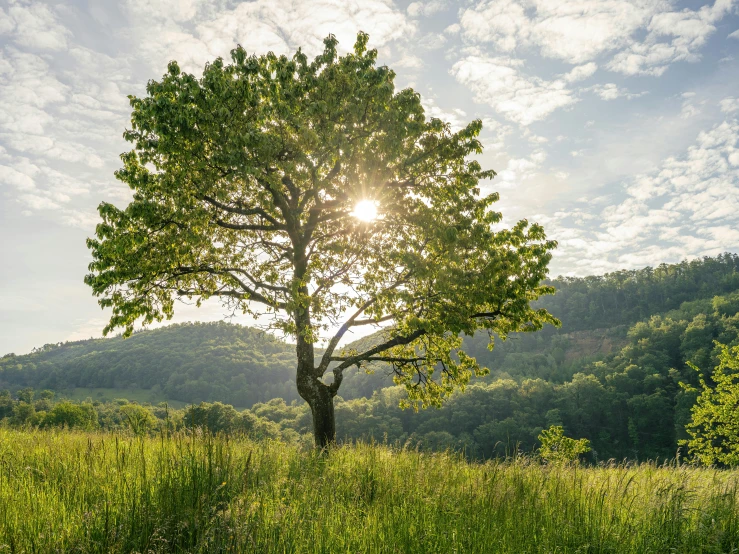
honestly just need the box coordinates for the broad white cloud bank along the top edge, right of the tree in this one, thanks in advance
[460,0,733,75]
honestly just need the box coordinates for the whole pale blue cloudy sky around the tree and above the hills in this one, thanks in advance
[0,0,739,355]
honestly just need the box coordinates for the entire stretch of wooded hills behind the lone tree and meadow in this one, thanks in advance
[0,254,739,461]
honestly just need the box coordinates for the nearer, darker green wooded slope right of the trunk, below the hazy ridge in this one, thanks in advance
[252,291,739,461]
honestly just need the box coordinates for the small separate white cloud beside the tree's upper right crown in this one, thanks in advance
[451,55,578,125]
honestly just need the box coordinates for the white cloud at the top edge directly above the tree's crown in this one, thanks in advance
[125,0,416,71]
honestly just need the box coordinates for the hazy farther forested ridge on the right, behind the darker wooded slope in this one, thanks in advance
[340,253,739,398]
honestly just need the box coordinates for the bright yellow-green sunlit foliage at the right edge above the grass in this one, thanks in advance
[680,342,739,467]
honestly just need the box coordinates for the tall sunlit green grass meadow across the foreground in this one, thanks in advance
[0,428,739,554]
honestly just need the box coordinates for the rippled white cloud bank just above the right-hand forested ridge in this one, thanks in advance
[541,121,739,273]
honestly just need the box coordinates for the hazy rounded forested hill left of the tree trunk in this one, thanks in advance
[0,323,297,407]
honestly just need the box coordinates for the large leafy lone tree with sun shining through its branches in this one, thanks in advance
[85,33,558,446]
